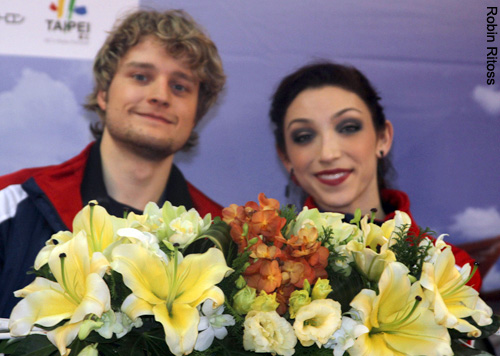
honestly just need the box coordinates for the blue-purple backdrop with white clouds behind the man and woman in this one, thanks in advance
[0,0,500,300]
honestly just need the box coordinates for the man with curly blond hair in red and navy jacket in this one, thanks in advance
[0,10,225,317]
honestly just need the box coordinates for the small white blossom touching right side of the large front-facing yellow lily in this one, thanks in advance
[194,299,235,351]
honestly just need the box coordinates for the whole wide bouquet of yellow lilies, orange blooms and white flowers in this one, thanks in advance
[0,194,500,356]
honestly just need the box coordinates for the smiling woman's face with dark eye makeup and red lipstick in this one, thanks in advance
[280,86,392,213]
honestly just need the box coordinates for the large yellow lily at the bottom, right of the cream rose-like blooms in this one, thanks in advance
[348,262,453,356]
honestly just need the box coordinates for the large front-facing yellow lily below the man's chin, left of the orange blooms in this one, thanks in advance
[112,244,232,355]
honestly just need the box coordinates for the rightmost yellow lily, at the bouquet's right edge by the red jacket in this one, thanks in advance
[420,246,493,337]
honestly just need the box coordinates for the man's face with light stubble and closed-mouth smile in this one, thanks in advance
[97,37,199,160]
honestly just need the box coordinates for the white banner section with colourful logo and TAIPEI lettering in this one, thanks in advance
[0,0,139,59]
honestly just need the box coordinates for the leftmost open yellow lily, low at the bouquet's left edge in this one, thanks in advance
[9,232,111,355]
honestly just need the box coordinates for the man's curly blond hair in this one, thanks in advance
[85,10,226,149]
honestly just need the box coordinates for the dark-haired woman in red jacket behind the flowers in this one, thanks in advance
[270,62,481,290]
